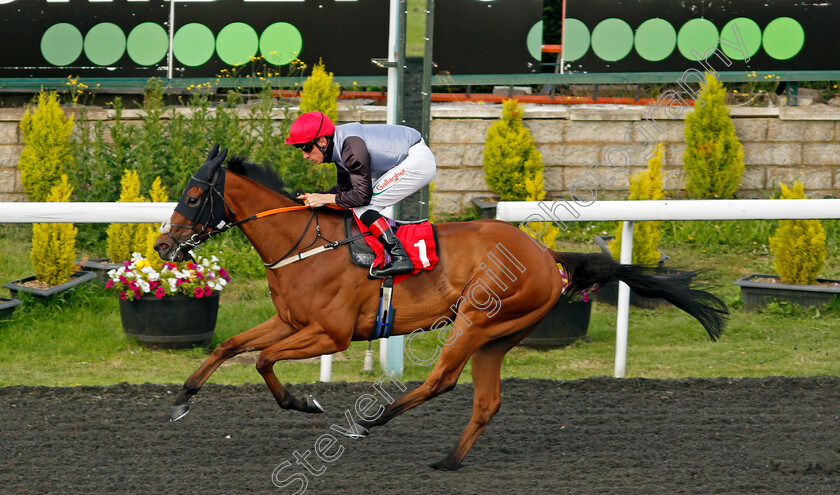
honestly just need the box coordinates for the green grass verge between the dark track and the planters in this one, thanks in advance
[0,226,840,386]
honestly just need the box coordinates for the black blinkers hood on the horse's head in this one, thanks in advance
[175,144,228,229]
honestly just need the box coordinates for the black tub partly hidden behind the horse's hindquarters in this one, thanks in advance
[520,297,592,347]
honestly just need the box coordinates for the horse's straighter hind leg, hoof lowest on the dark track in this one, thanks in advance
[432,330,528,471]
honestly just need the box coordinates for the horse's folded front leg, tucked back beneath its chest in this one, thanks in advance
[257,323,352,413]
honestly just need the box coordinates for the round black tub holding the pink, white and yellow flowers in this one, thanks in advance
[120,292,219,349]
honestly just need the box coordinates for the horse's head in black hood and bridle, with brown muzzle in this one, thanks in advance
[155,144,231,261]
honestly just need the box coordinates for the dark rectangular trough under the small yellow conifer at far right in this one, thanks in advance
[735,273,840,311]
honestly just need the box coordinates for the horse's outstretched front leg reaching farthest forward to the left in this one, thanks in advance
[170,315,295,421]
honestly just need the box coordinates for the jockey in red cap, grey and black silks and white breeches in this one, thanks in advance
[286,112,435,278]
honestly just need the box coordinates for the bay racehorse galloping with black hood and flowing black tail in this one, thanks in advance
[155,146,728,470]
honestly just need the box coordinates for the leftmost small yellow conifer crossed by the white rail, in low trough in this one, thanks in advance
[30,174,79,286]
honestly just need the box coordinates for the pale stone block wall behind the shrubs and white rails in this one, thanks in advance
[0,104,840,213]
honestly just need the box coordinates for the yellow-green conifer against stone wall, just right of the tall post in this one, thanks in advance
[483,99,544,201]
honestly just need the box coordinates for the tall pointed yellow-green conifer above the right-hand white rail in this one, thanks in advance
[683,73,744,199]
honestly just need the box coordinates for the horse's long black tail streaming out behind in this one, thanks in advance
[552,251,729,340]
